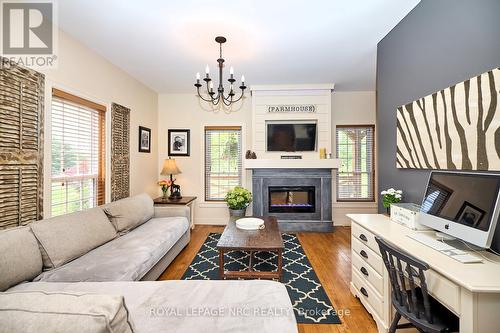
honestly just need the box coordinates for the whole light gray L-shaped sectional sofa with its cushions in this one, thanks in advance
[0,194,297,333]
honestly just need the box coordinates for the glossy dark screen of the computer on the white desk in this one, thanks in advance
[420,172,500,231]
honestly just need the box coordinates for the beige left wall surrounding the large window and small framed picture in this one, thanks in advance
[44,31,158,212]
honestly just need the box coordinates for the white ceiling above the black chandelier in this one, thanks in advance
[58,0,419,93]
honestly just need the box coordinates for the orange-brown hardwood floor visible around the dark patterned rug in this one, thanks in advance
[160,225,377,333]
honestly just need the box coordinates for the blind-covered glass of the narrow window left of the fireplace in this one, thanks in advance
[205,126,242,201]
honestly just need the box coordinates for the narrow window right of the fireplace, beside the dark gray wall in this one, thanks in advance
[337,125,375,201]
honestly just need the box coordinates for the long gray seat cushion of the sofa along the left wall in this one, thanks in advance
[35,217,189,282]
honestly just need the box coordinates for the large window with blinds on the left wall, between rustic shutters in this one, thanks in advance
[51,89,106,216]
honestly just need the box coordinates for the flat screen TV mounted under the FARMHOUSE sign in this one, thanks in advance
[267,123,316,152]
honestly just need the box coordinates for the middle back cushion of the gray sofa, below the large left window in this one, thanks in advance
[30,208,117,268]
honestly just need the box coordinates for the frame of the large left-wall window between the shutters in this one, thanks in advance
[50,87,107,217]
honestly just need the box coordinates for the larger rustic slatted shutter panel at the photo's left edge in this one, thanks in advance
[0,58,44,229]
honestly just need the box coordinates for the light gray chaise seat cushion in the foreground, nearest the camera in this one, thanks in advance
[8,280,297,333]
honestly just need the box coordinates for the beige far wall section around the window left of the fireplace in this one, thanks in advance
[156,92,252,224]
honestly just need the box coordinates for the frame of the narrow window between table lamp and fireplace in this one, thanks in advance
[200,124,245,201]
